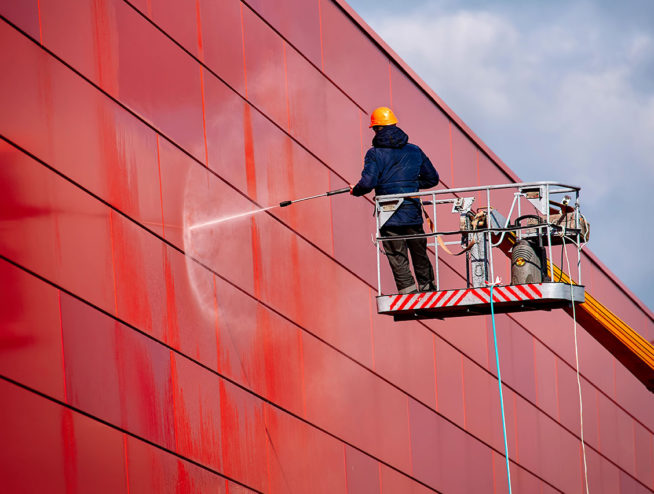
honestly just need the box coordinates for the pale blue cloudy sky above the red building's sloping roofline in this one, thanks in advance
[348,0,654,310]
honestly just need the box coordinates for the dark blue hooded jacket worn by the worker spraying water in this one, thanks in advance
[352,125,438,226]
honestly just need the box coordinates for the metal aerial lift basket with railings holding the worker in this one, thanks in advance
[375,182,589,320]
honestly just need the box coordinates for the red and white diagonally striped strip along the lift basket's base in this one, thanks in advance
[389,283,543,311]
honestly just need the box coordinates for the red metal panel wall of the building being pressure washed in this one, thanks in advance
[0,0,654,494]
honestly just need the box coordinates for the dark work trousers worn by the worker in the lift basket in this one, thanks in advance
[380,225,436,293]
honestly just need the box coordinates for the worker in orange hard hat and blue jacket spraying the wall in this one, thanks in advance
[350,107,438,293]
